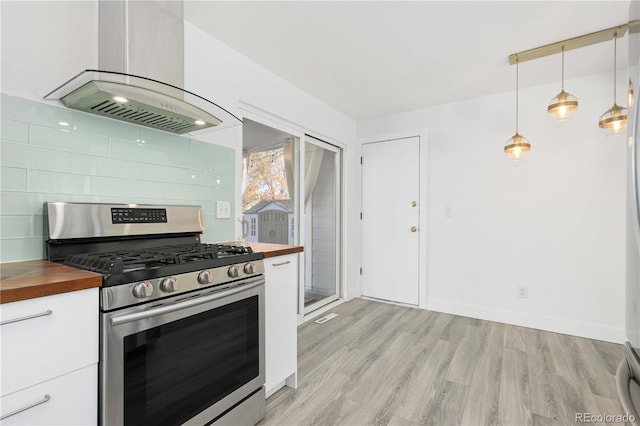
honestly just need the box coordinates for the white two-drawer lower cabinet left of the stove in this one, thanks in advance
[0,288,99,425]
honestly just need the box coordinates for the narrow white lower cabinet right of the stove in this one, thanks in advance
[264,253,298,396]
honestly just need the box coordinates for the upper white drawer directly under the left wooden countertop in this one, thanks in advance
[0,288,98,396]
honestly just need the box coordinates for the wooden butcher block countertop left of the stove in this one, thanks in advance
[0,260,102,303]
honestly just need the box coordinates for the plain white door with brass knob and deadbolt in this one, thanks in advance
[362,136,420,305]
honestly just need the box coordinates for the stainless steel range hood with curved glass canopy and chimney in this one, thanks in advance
[45,0,241,134]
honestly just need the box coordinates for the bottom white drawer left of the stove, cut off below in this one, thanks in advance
[0,364,98,426]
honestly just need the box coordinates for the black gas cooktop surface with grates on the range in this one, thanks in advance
[64,244,263,286]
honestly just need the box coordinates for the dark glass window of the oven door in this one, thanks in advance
[124,296,260,425]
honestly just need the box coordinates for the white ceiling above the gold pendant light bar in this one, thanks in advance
[185,0,629,119]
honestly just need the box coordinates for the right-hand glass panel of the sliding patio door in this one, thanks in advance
[301,135,341,313]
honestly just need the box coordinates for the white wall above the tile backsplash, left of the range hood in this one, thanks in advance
[0,1,98,102]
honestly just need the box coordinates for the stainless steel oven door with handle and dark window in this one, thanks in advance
[100,276,264,425]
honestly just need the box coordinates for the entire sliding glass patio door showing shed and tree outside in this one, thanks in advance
[242,118,342,315]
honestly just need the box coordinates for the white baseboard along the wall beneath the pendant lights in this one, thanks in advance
[427,299,627,343]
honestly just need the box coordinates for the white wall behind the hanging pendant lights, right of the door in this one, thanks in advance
[358,70,626,342]
